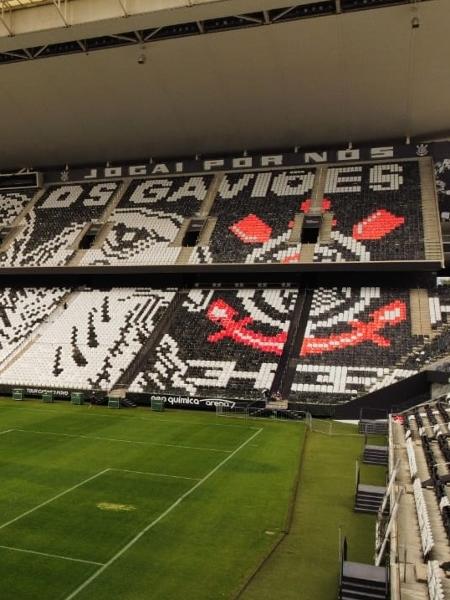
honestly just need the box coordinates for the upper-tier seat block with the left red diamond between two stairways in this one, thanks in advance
[190,169,315,264]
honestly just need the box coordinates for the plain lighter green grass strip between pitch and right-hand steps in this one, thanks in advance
[241,424,385,600]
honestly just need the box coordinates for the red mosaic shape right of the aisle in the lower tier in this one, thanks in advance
[300,300,406,356]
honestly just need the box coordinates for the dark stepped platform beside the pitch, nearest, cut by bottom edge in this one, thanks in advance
[339,561,388,600]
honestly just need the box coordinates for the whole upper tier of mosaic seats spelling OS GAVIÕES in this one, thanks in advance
[0,159,425,267]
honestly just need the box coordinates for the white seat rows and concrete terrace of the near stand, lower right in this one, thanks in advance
[391,403,448,600]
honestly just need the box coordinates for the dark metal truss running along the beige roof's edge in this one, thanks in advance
[0,0,431,65]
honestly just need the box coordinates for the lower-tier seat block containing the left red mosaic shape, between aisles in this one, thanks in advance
[130,289,297,399]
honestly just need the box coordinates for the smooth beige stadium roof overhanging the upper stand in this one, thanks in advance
[0,0,450,169]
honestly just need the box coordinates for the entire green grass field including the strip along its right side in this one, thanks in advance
[0,399,383,600]
